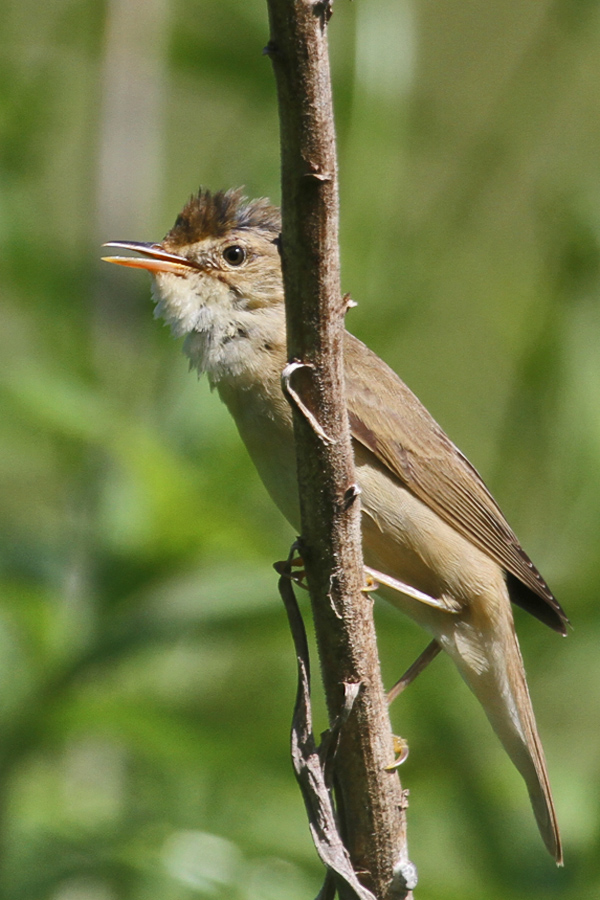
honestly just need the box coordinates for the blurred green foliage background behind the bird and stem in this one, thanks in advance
[0,0,600,900]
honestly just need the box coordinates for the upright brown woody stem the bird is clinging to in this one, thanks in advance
[267,0,414,900]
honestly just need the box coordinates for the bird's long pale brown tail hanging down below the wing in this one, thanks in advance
[439,609,563,866]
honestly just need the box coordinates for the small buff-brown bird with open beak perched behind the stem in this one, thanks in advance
[106,190,568,865]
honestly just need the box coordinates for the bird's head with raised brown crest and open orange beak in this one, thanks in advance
[105,189,283,374]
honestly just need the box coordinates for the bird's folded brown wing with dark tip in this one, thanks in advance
[345,334,568,634]
